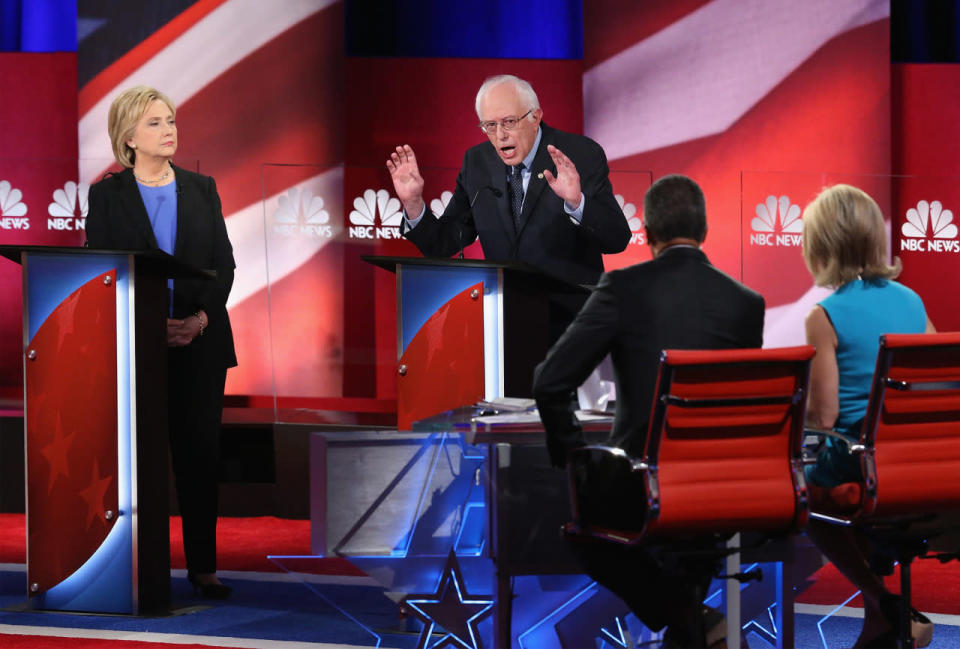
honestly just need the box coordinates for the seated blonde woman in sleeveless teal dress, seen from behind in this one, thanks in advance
[803,185,934,649]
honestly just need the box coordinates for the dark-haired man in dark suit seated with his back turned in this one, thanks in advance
[534,176,764,647]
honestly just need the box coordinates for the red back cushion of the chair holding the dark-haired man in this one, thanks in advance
[645,346,814,535]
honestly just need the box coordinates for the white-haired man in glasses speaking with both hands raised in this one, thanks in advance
[387,75,630,284]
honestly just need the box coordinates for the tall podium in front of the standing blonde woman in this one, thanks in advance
[0,246,212,615]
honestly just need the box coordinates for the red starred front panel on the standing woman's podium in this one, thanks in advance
[24,268,119,592]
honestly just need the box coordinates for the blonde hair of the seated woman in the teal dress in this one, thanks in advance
[803,185,901,287]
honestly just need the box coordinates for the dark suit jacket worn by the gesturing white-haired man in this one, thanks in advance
[405,122,630,284]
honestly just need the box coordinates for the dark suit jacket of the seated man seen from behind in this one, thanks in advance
[534,247,764,466]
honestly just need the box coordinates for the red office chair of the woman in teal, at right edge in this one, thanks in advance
[811,333,960,647]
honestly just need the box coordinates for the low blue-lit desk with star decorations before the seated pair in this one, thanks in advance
[311,409,808,649]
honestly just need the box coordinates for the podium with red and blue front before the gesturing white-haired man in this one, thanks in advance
[363,255,587,430]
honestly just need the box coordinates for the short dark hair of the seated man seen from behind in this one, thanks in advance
[643,174,707,243]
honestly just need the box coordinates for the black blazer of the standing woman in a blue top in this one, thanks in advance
[86,166,237,367]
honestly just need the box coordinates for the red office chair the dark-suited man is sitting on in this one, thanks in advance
[566,346,814,634]
